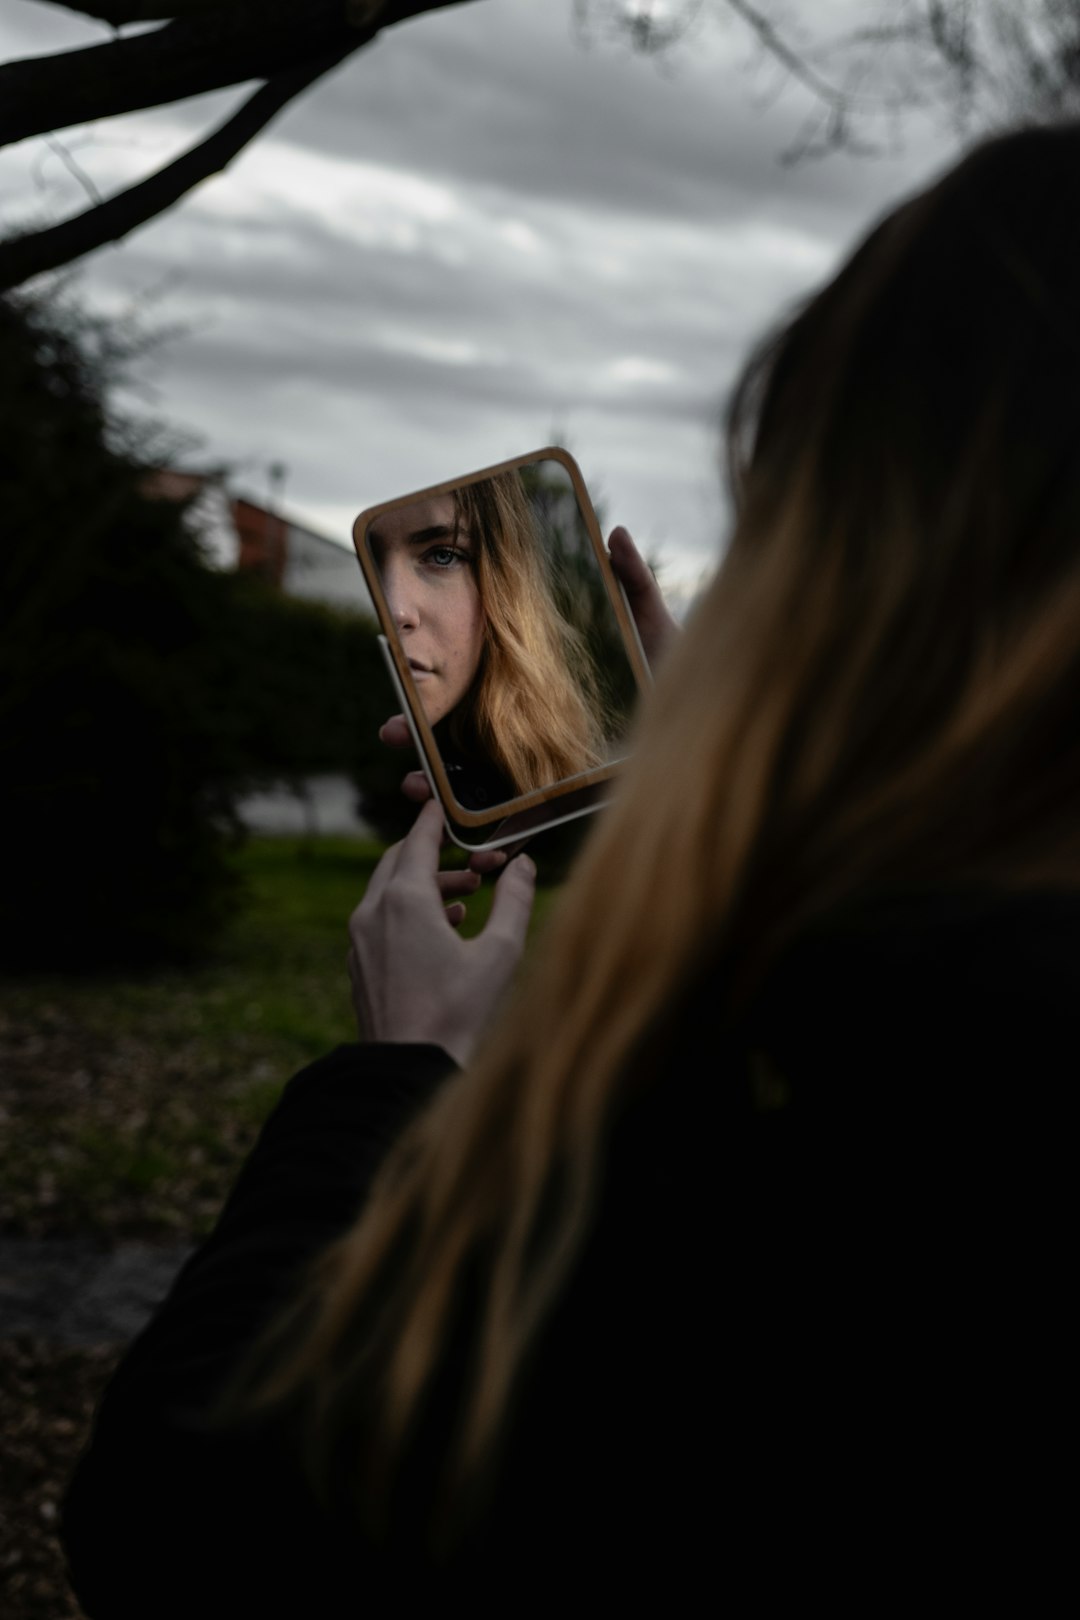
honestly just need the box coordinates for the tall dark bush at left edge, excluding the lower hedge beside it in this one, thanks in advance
[0,300,246,969]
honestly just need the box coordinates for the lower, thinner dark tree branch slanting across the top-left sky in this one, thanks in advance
[0,45,358,292]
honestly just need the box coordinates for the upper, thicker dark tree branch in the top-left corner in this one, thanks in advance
[0,0,482,146]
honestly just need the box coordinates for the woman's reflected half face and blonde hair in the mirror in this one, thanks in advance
[368,468,609,808]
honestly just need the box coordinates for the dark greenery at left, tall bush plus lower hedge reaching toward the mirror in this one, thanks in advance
[0,298,400,970]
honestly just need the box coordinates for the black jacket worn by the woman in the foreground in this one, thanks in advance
[63,896,1080,1620]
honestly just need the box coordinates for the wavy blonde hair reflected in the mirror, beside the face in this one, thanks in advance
[450,470,606,794]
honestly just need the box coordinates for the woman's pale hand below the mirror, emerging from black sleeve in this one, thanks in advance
[348,800,536,1064]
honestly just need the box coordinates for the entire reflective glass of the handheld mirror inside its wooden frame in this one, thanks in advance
[366,458,638,810]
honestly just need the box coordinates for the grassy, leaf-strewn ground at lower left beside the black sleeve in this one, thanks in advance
[0,838,374,1620]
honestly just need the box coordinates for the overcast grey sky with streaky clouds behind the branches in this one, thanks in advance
[0,0,954,609]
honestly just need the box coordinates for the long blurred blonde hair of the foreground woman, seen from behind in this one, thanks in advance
[236,130,1080,1521]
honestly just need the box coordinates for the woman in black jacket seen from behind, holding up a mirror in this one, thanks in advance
[68,126,1080,1617]
